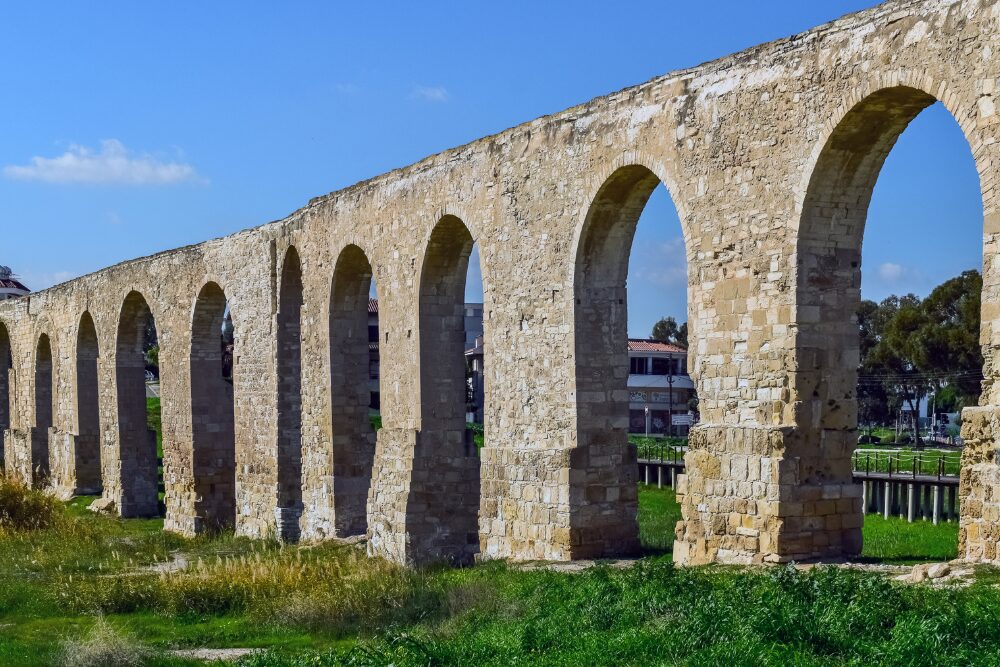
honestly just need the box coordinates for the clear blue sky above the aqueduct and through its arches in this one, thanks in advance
[0,0,982,335]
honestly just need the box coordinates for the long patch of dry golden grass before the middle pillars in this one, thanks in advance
[60,545,449,634]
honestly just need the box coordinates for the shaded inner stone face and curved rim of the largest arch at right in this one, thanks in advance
[792,83,989,558]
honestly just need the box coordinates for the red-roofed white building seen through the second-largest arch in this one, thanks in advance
[628,338,695,436]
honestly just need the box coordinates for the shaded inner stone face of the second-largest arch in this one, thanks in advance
[570,163,693,557]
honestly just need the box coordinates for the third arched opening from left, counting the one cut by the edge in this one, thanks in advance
[75,312,101,495]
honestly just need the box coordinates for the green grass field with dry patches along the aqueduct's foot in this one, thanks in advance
[0,470,984,667]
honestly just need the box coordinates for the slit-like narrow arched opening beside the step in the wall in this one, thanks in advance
[275,247,302,541]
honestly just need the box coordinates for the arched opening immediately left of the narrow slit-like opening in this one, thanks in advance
[190,282,236,530]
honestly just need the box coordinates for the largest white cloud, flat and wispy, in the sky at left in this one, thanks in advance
[3,139,200,185]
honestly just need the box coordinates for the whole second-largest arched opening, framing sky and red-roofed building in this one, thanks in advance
[570,165,693,558]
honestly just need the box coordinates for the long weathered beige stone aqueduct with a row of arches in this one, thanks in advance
[0,0,1000,564]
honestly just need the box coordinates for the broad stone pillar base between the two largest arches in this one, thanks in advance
[674,424,862,565]
